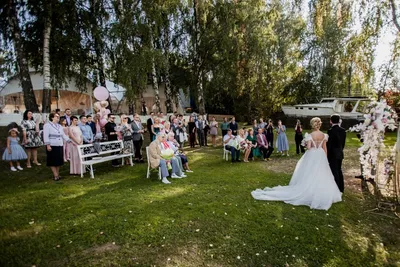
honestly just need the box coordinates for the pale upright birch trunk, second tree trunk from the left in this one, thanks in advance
[42,12,51,113]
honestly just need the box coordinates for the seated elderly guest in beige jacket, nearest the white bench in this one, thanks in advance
[149,133,186,184]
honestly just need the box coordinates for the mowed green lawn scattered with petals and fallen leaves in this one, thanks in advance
[0,128,400,266]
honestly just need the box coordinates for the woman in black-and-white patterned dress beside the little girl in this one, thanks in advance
[21,110,43,168]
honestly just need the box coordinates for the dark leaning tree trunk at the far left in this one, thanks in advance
[7,0,39,112]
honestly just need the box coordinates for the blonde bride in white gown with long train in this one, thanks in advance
[251,118,342,210]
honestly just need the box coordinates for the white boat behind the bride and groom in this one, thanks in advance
[282,97,371,120]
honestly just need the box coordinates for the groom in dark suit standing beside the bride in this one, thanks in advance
[326,114,346,193]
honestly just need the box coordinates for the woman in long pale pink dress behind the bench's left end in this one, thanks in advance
[69,116,83,175]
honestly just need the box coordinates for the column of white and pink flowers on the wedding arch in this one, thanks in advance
[349,100,397,179]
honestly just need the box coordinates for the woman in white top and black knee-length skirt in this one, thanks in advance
[43,113,70,181]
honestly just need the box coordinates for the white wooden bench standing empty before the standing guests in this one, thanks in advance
[78,140,133,178]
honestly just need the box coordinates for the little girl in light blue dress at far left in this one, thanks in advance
[3,128,28,172]
